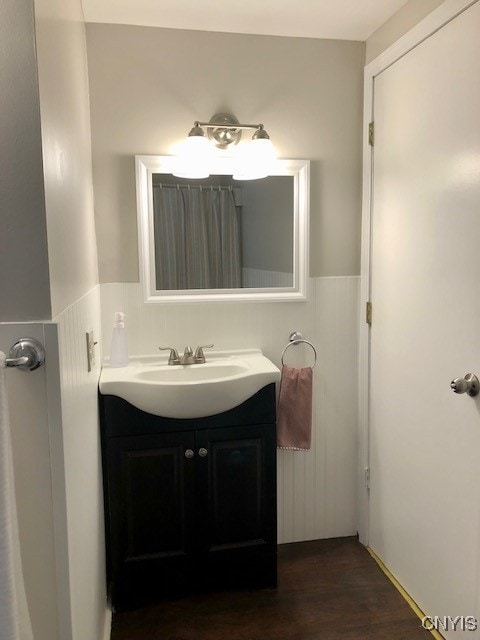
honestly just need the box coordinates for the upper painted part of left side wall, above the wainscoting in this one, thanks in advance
[35,0,98,317]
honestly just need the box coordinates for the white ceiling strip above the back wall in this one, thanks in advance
[82,0,406,40]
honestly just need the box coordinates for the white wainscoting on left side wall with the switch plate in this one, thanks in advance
[54,287,111,640]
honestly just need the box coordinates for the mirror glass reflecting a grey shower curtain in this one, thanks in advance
[152,173,293,290]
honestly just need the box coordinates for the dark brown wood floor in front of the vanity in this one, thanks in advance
[111,538,432,640]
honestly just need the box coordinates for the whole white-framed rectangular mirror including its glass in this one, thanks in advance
[135,156,310,303]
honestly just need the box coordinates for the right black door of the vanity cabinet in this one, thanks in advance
[196,425,276,586]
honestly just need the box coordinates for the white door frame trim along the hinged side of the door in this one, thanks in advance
[357,0,480,546]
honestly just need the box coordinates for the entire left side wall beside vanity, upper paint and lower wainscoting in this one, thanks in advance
[35,0,110,640]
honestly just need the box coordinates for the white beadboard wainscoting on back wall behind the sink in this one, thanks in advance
[100,277,359,542]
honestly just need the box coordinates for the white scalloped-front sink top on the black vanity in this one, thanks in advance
[99,349,280,418]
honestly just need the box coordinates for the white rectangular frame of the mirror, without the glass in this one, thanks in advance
[135,155,310,304]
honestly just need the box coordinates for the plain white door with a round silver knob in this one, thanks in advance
[369,3,480,638]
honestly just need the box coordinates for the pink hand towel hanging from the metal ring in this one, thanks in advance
[277,364,313,451]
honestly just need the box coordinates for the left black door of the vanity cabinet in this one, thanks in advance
[107,431,195,609]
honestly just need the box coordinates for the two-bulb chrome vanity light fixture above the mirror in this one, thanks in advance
[173,113,276,180]
